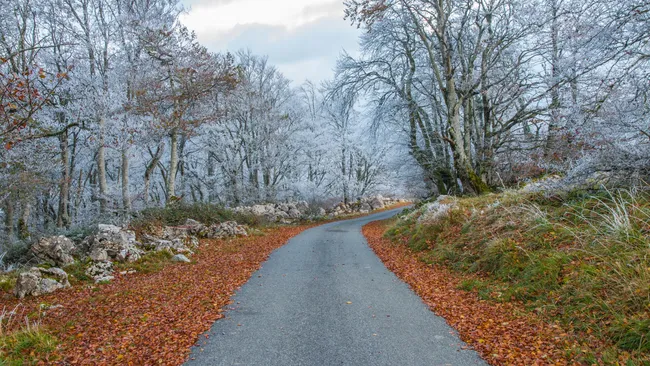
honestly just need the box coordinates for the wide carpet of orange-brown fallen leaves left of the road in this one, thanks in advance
[0,226,308,365]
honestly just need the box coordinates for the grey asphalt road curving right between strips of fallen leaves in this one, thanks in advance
[186,210,485,366]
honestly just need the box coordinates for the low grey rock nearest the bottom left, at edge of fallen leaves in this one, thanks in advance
[14,267,70,299]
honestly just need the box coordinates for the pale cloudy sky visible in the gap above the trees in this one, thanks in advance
[181,0,360,84]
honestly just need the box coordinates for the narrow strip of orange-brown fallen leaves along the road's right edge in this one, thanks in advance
[363,222,579,366]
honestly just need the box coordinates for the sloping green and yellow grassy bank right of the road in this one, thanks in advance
[386,189,650,365]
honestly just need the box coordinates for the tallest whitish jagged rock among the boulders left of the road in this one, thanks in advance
[82,225,144,262]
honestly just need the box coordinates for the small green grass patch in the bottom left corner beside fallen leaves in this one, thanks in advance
[0,307,58,366]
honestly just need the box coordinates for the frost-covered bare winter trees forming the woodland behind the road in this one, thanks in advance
[0,0,650,250]
